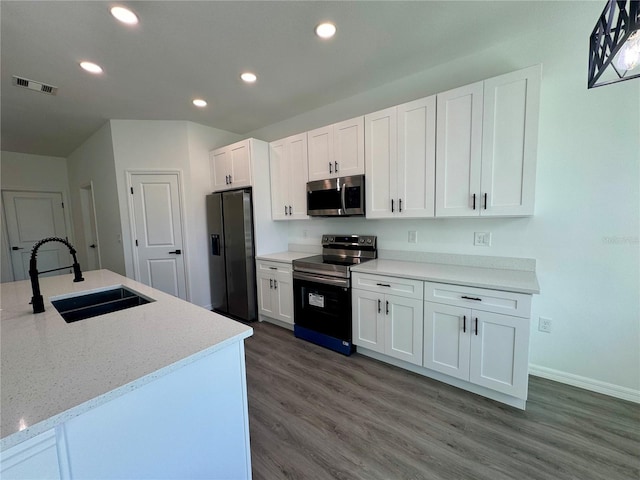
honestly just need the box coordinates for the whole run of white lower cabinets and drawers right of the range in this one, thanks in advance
[352,272,531,408]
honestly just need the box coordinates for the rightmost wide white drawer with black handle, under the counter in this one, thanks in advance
[424,282,531,318]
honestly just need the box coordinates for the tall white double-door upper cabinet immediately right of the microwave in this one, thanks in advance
[365,96,436,218]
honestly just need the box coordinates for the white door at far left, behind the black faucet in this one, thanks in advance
[2,190,73,281]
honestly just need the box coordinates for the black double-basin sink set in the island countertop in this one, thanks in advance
[51,286,154,323]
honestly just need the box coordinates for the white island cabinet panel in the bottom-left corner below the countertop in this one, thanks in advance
[0,429,60,480]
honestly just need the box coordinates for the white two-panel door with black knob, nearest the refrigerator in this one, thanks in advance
[130,173,187,300]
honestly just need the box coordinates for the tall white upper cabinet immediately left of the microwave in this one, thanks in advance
[269,133,309,220]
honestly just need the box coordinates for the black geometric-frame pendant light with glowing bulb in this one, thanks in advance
[587,0,640,88]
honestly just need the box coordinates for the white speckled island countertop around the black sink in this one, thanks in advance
[0,270,253,450]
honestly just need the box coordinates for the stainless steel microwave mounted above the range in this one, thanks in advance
[307,175,364,217]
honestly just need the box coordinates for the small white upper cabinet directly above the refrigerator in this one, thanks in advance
[209,139,252,192]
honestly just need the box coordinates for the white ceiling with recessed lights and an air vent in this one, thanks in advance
[0,0,576,157]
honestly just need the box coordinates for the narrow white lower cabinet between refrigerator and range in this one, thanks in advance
[256,260,293,326]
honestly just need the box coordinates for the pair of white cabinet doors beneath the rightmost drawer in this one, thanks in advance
[424,302,529,399]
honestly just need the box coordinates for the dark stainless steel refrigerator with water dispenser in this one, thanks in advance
[207,189,257,322]
